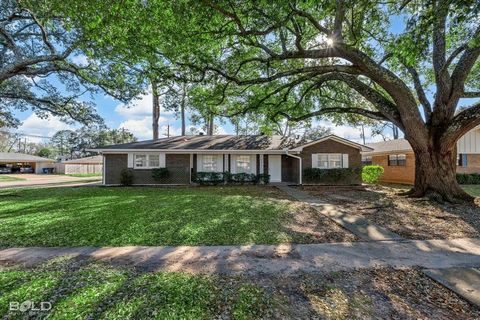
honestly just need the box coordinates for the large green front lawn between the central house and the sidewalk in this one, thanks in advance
[0,186,305,247]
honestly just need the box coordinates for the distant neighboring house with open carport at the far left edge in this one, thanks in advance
[0,152,55,173]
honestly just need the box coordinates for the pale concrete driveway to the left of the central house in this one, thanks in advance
[0,173,102,189]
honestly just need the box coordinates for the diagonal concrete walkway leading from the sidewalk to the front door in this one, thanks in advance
[276,184,403,241]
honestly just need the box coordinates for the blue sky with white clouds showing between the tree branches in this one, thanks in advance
[8,13,404,142]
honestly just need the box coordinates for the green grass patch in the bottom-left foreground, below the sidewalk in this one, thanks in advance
[0,260,269,319]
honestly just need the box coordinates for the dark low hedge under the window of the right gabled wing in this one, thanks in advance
[303,167,362,184]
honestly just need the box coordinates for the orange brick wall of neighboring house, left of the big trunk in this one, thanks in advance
[372,153,415,184]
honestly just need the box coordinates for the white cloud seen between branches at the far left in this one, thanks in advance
[18,113,75,142]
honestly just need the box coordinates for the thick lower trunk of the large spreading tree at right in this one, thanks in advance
[406,146,474,202]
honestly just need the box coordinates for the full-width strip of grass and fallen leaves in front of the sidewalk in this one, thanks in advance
[0,256,480,319]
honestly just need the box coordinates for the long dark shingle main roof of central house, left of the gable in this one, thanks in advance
[98,135,284,150]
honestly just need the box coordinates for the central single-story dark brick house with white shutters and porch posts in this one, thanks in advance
[89,135,369,185]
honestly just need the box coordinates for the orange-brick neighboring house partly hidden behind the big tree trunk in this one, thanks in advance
[362,127,480,184]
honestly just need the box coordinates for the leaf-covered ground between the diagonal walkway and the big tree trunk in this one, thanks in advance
[302,186,480,240]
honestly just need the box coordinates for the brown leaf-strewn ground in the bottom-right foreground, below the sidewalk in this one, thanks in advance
[257,268,480,319]
